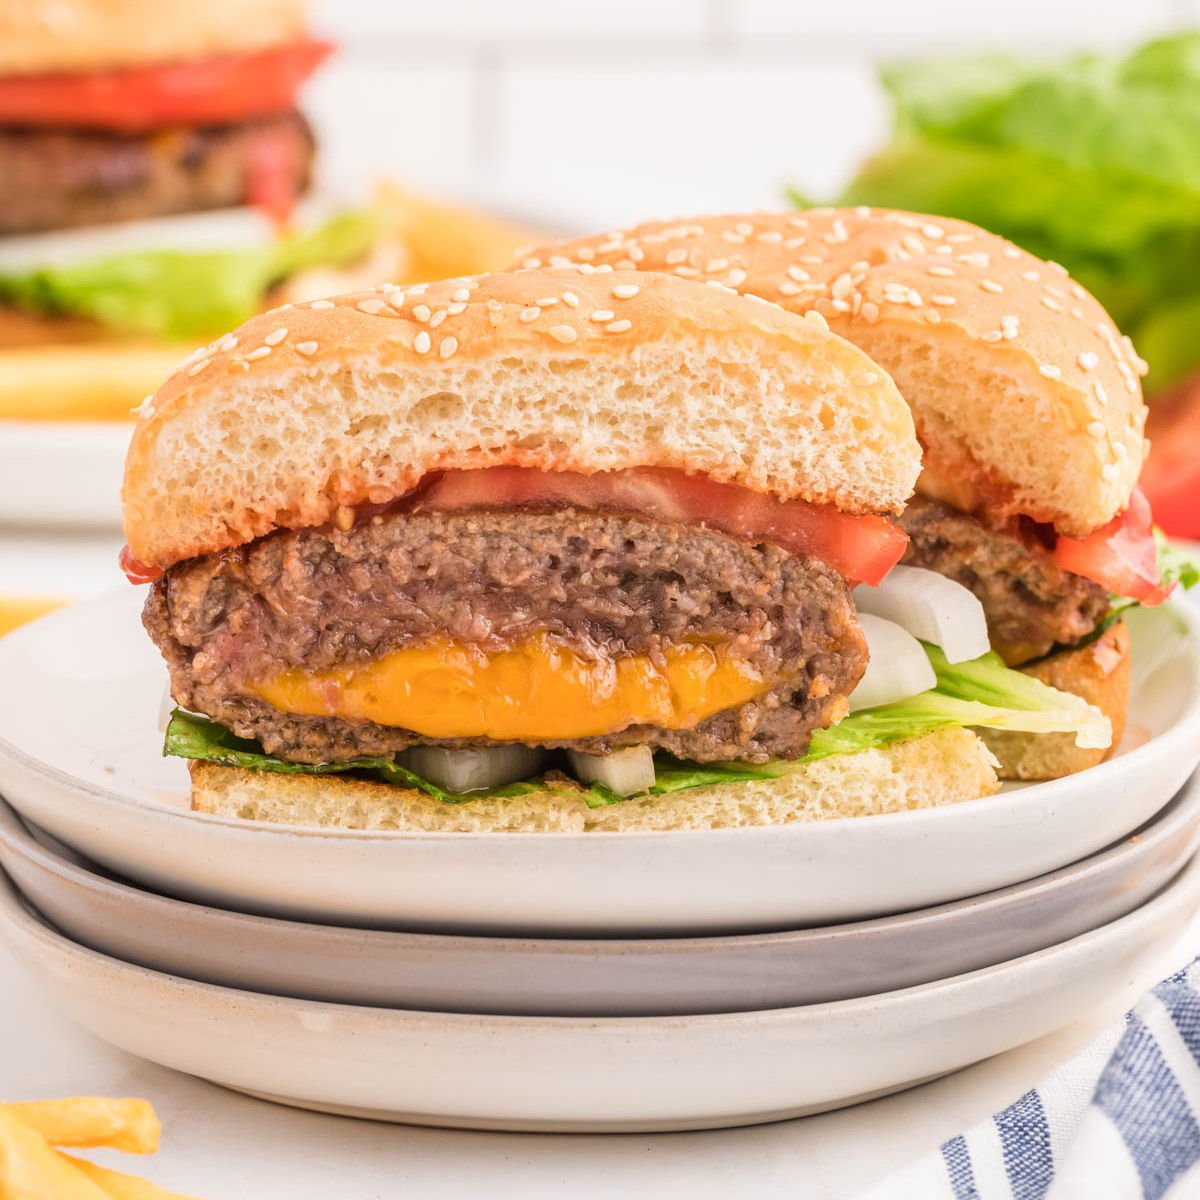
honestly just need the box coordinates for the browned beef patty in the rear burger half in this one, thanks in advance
[900,496,1109,666]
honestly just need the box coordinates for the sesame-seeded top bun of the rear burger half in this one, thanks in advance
[520,208,1147,536]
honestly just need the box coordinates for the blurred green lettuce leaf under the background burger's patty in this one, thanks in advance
[0,212,378,338]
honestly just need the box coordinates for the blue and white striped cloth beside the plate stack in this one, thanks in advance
[859,959,1200,1200]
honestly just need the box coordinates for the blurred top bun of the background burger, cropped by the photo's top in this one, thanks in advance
[0,0,306,74]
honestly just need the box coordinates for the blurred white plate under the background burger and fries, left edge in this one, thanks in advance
[0,421,133,529]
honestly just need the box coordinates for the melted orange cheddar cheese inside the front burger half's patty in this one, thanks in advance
[251,635,770,742]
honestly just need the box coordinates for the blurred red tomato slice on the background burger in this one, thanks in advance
[0,38,334,133]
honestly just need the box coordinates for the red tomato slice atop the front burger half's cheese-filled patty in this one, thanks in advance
[414,467,908,583]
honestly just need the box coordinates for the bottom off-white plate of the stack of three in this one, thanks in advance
[0,862,1200,1132]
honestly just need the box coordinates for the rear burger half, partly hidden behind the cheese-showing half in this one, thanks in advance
[522,208,1190,779]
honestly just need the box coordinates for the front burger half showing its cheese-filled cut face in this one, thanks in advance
[124,268,1106,830]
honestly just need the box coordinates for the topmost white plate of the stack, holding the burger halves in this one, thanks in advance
[0,588,1200,936]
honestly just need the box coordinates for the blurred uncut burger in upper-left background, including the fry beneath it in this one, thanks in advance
[0,0,384,420]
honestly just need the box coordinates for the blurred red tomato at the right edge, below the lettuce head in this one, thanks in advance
[1141,374,1200,539]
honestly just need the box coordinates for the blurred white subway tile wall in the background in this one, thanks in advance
[306,0,1200,230]
